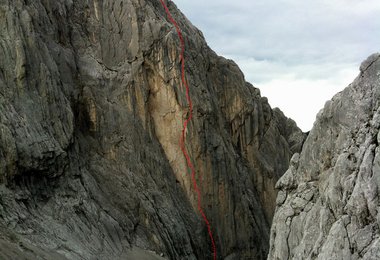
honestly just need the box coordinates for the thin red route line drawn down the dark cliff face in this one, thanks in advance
[160,0,216,260]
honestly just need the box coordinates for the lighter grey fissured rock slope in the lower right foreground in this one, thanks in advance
[268,54,380,260]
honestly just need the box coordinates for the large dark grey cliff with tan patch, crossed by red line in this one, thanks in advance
[0,0,304,260]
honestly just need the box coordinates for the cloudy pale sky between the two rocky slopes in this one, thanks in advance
[174,0,380,131]
